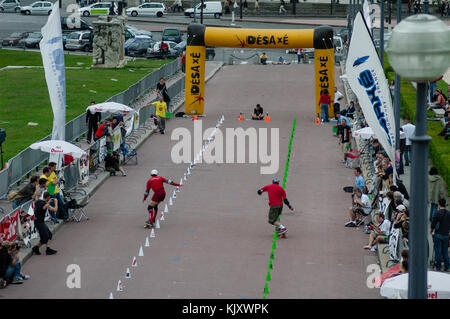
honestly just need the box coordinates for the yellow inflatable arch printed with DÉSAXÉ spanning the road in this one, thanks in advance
[185,23,334,117]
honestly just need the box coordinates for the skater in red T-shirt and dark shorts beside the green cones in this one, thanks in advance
[258,177,294,238]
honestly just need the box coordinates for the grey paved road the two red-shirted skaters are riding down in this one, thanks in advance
[0,65,379,299]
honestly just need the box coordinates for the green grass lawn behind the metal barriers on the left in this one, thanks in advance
[0,50,174,162]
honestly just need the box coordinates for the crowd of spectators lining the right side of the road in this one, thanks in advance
[335,88,450,278]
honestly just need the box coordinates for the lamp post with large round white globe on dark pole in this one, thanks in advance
[386,14,450,299]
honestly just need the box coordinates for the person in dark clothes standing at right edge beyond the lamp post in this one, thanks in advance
[431,198,450,271]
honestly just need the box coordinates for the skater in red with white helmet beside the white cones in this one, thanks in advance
[142,169,181,228]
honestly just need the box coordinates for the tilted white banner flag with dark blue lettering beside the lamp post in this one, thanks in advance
[345,12,396,174]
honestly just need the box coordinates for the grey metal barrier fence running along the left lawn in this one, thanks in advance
[0,59,181,199]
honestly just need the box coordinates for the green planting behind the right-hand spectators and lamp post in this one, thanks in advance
[384,56,450,192]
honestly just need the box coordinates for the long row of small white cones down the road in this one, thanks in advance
[109,115,225,299]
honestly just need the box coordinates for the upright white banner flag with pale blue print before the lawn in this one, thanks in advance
[39,1,66,165]
